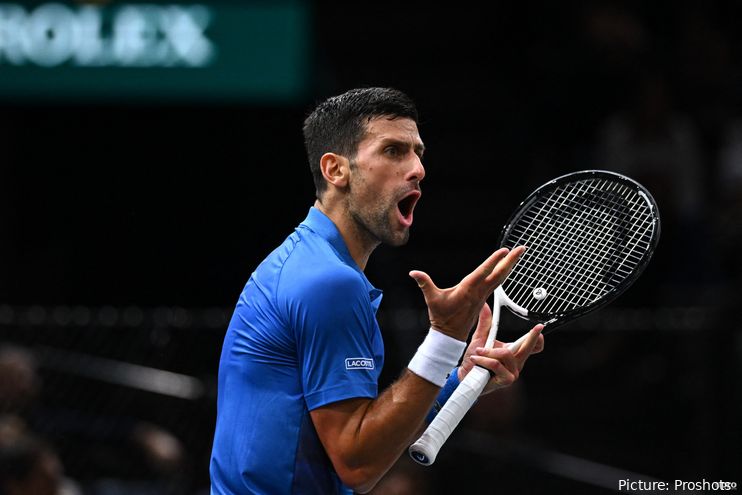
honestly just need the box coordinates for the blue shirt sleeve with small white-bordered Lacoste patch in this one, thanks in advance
[286,266,381,411]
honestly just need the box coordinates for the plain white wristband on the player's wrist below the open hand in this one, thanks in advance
[407,327,466,387]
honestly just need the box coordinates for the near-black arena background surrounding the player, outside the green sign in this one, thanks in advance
[0,1,742,493]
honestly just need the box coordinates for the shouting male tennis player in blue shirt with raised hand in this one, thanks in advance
[210,88,543,495]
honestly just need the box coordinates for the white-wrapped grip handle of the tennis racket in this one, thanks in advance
[409,366,490,466]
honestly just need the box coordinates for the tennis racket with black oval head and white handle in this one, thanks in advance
[409,170,660,466]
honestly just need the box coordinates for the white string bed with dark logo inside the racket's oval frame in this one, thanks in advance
[503,179,654,312]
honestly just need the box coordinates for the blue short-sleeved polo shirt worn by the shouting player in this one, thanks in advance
[210,208,384,495]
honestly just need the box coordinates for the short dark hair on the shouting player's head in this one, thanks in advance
[304,88,418,198]
